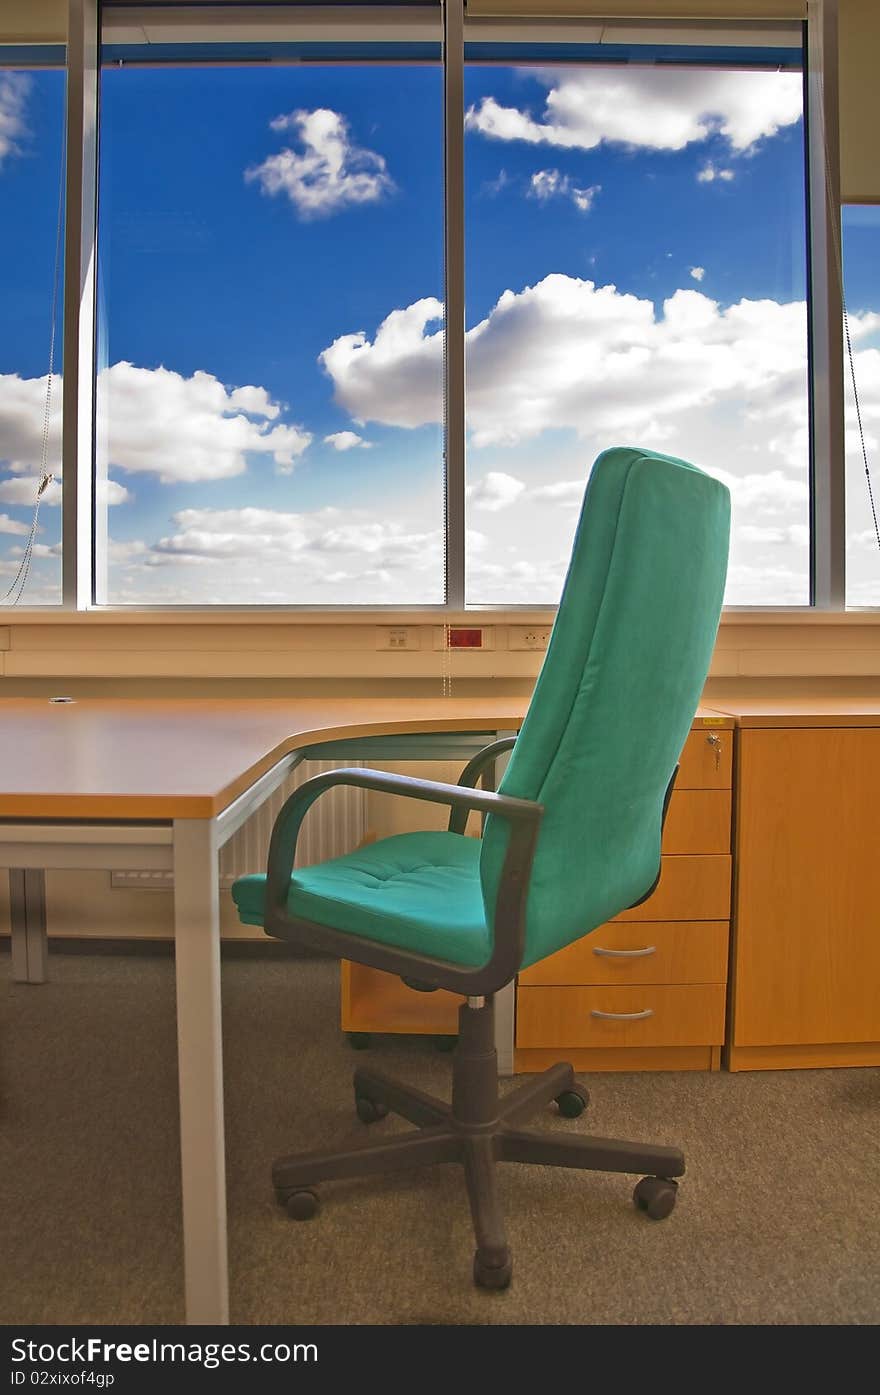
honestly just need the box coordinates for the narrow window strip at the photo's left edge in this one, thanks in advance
[0,61,64,605]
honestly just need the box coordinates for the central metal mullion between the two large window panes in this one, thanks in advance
[443,0,464,610]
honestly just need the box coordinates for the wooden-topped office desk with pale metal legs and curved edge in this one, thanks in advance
[0,698,526,1322]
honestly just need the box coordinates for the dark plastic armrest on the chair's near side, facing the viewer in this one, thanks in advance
[264,769,544,995]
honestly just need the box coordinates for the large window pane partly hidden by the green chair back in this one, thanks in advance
[464,45,810,605]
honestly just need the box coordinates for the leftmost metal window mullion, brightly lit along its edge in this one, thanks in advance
[61,0,98,610]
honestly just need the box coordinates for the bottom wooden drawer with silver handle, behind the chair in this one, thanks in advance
[516,983,725,1049]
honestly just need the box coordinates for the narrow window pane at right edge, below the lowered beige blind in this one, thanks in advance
[842,204,880,605]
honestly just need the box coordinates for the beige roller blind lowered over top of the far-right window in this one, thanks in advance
[838,0,880,204]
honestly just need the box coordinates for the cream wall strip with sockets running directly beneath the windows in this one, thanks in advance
[0,611,880,696]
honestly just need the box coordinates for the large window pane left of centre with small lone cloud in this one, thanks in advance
[98,61,443,605]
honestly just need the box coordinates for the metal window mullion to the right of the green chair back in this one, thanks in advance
[806,0,847,611]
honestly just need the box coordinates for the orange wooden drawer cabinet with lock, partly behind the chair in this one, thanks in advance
[515,714,734,1071]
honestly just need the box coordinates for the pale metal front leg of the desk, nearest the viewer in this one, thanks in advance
[174,819,229,1324]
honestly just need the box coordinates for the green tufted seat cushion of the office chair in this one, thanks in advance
[232,831,491,967]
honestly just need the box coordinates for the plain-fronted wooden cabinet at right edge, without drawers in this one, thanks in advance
[725,699,880,1070]
